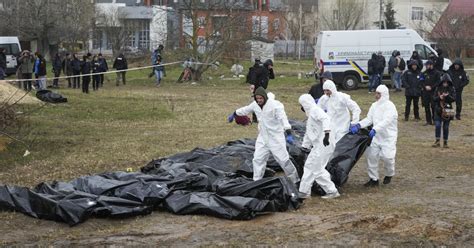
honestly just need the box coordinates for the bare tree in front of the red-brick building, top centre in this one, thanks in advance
[178,0,251,80]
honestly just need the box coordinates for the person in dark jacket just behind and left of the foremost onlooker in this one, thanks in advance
[421,60,441,126]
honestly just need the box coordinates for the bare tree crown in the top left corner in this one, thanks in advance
[0,0,94,55]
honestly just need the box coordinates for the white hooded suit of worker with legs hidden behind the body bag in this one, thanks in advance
[318,80,360,143]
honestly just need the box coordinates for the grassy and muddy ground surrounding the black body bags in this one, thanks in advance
[0,61,474,247]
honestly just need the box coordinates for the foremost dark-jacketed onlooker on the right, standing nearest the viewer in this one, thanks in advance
[433,73,456,148]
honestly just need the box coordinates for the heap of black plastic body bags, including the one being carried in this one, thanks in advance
[0,121,369,225]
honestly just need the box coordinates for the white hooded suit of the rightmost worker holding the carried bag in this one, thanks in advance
[359,85,398,181]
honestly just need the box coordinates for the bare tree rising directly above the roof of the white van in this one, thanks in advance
[320,0,364,30]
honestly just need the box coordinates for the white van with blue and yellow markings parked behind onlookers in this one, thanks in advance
[314,29,451,90]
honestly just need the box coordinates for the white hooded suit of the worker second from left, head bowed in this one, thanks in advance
[299,94,337,195]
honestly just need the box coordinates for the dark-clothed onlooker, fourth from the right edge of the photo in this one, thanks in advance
[402,60,421,121]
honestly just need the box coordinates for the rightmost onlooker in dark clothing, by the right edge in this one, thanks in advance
[448,59,469,120]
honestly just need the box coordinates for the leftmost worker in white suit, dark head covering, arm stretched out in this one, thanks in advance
[227,87,300,184]
